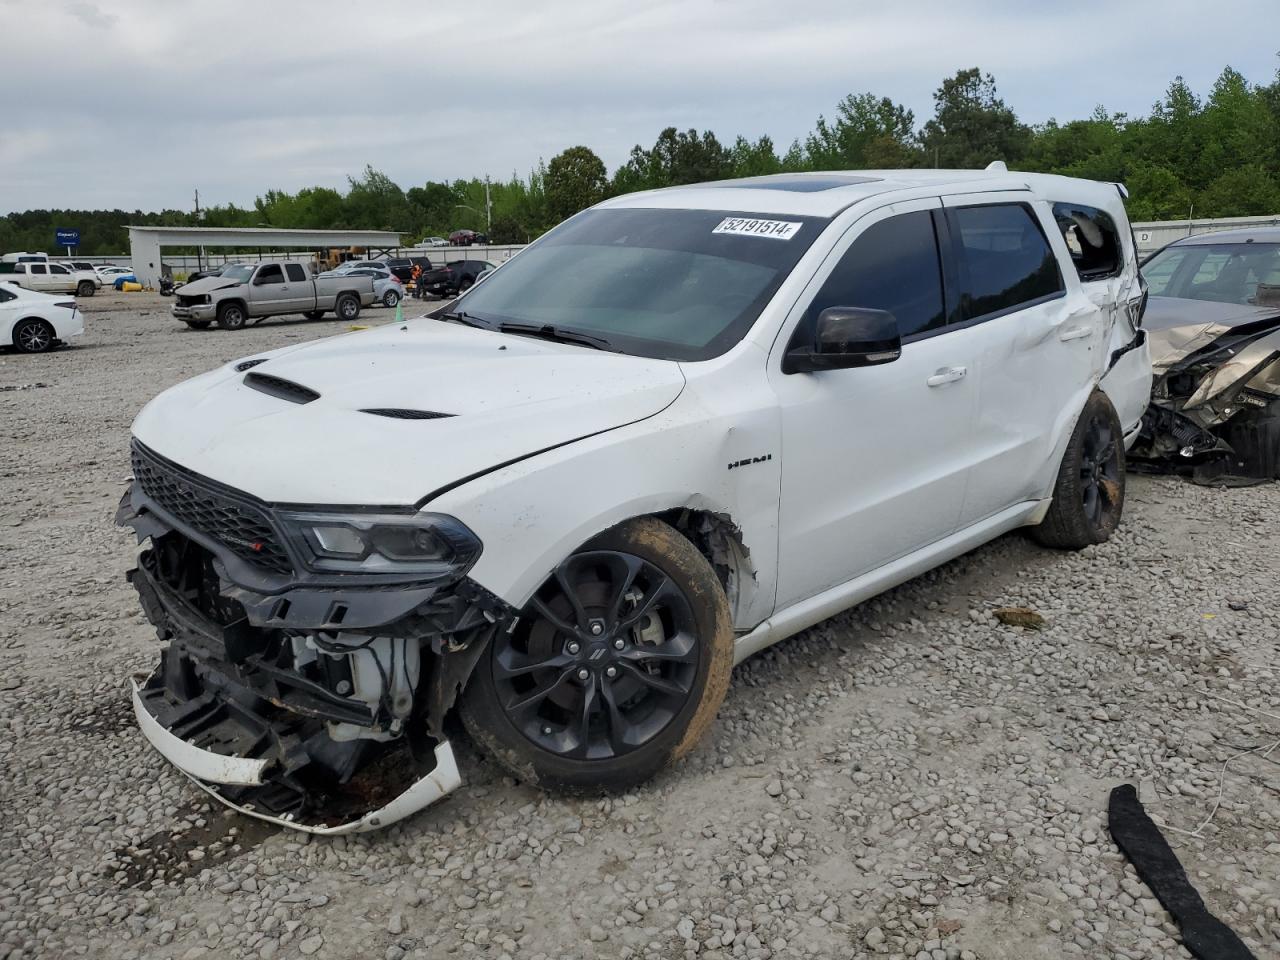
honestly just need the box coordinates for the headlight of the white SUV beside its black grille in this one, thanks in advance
[280,513,481,580]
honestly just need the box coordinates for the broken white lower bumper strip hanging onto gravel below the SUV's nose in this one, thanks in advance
[133,681,462,836]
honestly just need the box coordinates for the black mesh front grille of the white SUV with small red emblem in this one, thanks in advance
[132,442,293,573]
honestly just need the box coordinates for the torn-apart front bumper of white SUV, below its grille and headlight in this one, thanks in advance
[116,471,515,835]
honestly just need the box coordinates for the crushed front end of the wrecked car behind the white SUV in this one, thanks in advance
[1129,297,1280,484]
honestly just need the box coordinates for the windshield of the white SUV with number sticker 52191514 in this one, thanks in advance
[456,210,827,360]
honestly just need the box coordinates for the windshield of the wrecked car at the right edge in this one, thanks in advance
[1142,243,1280,306]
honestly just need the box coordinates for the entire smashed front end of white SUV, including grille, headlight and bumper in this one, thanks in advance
[116,442,515,833]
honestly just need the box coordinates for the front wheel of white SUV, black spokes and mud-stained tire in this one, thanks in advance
[460,518,733,792]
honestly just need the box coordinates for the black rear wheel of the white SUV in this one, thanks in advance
[1030,390,1125,550]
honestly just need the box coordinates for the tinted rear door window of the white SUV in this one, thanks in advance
[947,204,1064,320]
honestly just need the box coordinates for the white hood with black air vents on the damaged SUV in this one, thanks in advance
[133,321,685,506]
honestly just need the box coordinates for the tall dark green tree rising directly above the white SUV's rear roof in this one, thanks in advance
[920,67,1032,170]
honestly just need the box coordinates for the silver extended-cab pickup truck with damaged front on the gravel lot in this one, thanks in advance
[172,260,374,330]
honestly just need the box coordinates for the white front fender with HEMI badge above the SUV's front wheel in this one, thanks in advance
[424,398,781,630]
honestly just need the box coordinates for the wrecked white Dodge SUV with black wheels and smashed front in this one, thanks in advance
[119,165,1151,832]
